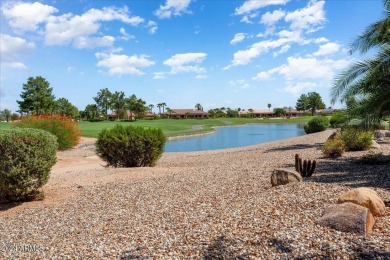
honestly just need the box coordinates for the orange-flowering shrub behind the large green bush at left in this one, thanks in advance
[15,115,81,150]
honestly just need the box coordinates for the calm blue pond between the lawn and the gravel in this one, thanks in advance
[165,124,305,152]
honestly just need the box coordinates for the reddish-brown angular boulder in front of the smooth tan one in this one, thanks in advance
[316,202,375,236]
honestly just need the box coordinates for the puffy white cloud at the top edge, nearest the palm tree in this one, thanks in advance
[284,1,326,32]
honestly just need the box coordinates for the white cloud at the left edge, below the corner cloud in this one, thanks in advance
[0,34,35,69]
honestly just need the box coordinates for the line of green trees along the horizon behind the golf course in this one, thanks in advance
[9,76,325,121]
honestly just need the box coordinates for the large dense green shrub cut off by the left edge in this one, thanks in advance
[0,128,58,201]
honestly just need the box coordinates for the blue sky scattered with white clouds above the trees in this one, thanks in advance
[0,0,383,111]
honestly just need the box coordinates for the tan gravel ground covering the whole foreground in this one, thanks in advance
[0,131,390,259]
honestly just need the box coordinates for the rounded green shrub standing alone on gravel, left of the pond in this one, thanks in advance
[96,125,166,167]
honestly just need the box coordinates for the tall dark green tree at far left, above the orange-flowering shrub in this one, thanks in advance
[16,76,55,115]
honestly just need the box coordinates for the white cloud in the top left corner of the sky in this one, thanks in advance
[2,2,58,32]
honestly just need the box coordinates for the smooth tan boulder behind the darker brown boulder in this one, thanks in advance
[337,187,386,216]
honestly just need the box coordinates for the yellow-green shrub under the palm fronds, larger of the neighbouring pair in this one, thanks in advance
[341,127,372,151]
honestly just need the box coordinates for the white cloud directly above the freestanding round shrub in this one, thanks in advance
[95,52,155,75]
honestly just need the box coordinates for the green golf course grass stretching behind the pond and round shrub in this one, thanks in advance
[79,117,311,137]
